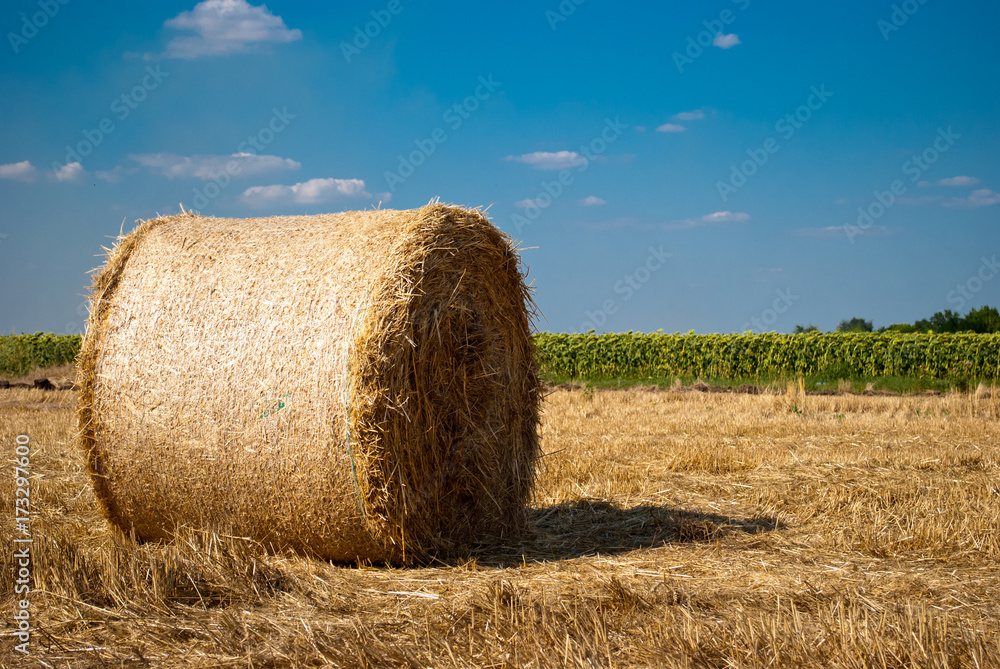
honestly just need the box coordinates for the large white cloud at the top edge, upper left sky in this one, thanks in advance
[162,0,302,59]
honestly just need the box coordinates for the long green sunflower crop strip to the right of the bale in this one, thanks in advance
[535,332,1000,380]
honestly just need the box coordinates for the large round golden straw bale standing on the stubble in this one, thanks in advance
[77,204,540,563]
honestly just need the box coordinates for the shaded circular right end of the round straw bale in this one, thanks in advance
[350,206,539,554]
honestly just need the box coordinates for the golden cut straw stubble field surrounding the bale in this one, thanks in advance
[0,378,1000,667]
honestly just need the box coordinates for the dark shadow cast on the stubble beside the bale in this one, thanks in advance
[472,500,785,566]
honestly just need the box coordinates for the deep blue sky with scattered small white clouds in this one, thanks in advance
[0,0,1000,333]
